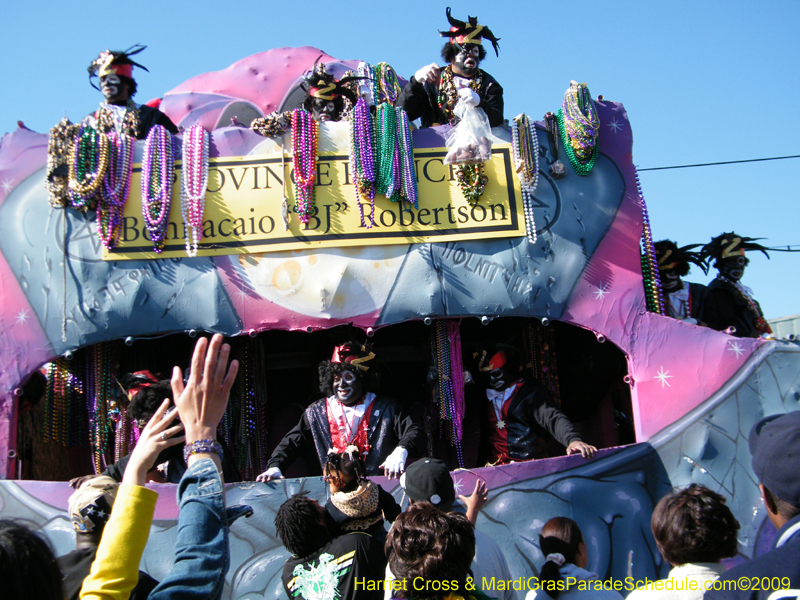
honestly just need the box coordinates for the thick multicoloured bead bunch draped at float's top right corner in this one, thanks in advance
[558,81,600,177]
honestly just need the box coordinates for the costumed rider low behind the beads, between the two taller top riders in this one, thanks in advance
[250,59,361,137]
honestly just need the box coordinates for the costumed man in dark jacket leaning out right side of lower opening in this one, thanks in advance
[478,345,597,465]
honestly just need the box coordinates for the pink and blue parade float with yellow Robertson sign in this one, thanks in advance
[0,47,800,598]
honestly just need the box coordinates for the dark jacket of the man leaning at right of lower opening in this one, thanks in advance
[496,379,581,460]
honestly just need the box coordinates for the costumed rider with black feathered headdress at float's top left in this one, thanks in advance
[83,45,178,140]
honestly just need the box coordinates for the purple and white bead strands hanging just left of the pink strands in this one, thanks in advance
[142,125,175,253]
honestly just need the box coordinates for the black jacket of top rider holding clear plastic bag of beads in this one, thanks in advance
[397,69,503,128]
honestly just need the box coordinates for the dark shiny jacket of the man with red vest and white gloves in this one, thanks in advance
[267,396,425,475]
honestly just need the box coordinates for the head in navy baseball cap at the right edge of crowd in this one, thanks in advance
[749,411,800,529]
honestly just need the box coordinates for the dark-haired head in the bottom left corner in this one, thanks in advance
[0,519,64,600]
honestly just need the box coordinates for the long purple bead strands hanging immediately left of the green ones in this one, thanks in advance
[350,98,375,229]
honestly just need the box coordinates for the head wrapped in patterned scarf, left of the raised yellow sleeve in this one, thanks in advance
[68,475,119,548]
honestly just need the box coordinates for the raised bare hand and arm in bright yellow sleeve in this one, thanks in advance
[81,400,184,600]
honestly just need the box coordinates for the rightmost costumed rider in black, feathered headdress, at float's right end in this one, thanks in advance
[701,231,772,337]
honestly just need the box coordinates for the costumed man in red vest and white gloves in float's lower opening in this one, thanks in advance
[256,343,425,481]
